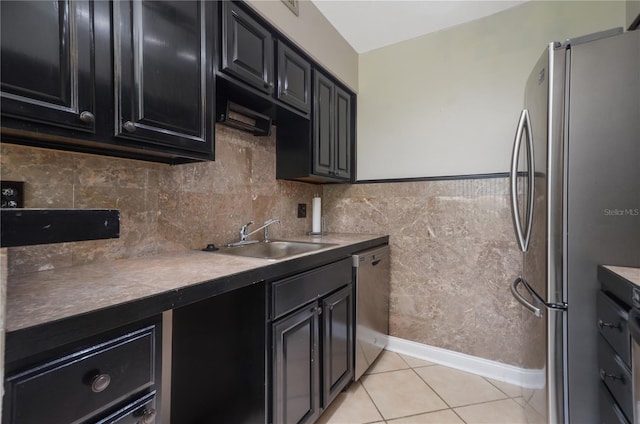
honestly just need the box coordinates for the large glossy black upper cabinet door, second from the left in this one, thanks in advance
[113,1,215,157]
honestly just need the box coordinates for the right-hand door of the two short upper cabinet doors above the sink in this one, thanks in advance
[277,41,311,112]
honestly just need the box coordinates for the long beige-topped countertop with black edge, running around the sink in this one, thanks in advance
[6,234,388,334]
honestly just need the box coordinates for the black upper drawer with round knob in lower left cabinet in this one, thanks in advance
[5,325,159,424]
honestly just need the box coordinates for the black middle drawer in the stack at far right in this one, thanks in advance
[598,337,633,418]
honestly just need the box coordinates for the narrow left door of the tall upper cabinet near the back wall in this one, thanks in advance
[313,72,335,176]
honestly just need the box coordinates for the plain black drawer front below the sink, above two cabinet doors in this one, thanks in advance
[271,258,351,319]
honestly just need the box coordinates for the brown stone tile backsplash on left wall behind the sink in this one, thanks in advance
[0,125,322,275]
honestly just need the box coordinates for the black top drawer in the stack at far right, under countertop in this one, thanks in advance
[597,291,631,368]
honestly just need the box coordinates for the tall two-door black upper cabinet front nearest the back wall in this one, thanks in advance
[312,71,353,180]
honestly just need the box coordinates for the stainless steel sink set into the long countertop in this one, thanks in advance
[218,240,335,259]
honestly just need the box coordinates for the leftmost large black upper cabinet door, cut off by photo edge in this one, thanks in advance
[0,1,95,132]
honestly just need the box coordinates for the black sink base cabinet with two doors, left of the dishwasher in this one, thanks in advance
[271,259,353,424]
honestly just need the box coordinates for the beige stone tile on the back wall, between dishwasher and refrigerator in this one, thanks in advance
[324,178,527,366]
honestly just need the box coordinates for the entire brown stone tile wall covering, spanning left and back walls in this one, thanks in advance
[0,132,528,367]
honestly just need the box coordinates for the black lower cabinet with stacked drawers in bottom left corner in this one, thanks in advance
[2,317,162,424]
